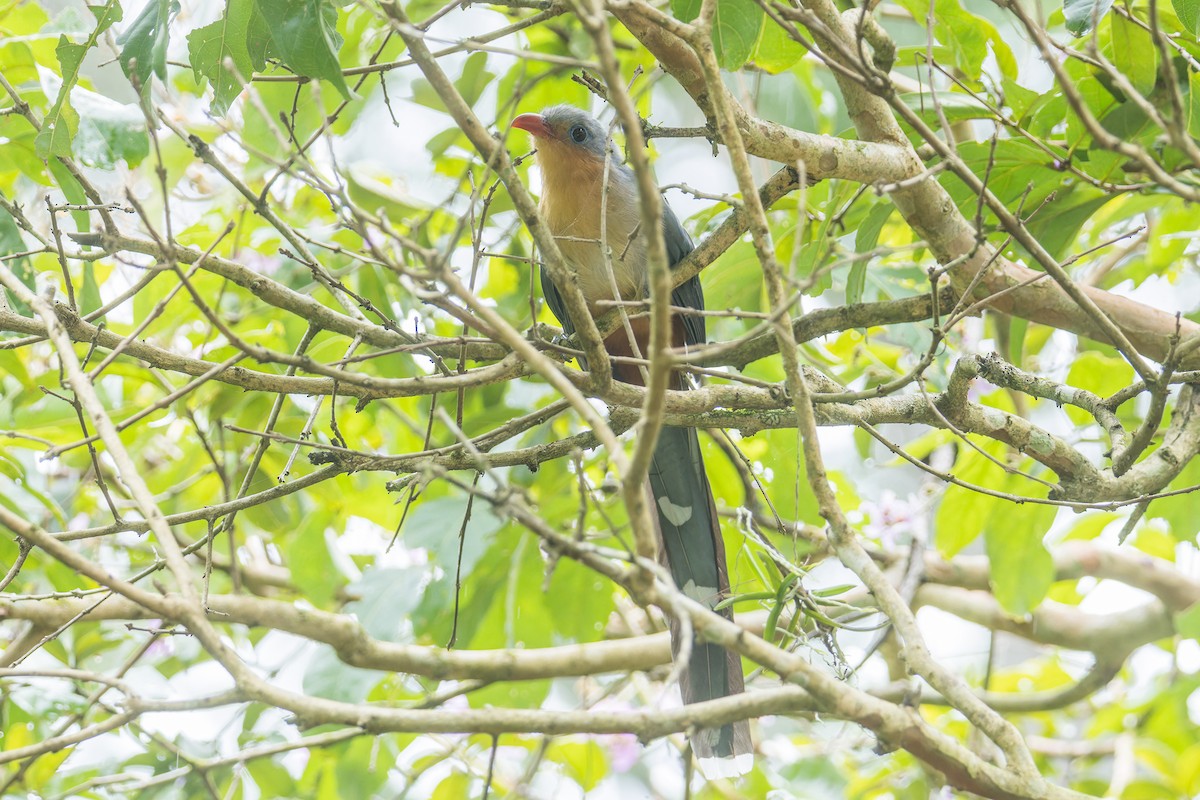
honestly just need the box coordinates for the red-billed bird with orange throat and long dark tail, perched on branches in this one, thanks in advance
[512,106,752,776]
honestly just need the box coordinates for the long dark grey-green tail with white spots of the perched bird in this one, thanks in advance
[649,426,752,775]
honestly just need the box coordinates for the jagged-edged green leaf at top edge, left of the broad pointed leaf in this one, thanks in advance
[187,0,254,115]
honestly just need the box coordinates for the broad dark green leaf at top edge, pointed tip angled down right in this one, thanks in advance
[248,0,353,100]
